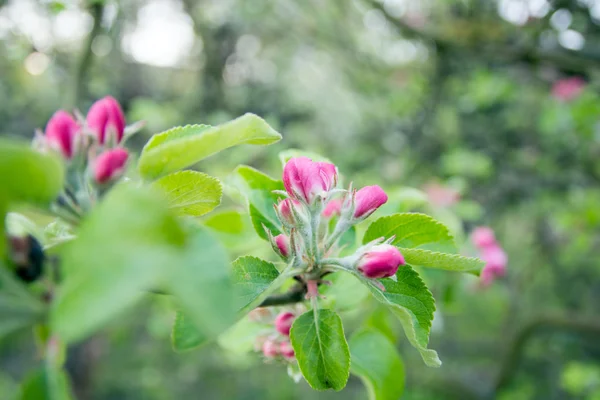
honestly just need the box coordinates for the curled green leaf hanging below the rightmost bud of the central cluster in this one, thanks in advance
[356,265,442,367]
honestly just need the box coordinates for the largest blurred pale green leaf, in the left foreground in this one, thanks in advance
[50,185,185,342]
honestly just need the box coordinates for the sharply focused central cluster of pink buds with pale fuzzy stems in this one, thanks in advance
[265,157,404,297]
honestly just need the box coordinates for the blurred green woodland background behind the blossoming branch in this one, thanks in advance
[0,0,600,400]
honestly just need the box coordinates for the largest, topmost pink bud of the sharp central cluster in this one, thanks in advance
[283,157,337,204]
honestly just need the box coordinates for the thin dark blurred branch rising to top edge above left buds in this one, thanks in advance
[67,1,104,108]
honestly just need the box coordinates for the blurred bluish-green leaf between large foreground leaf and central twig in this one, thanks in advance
[167,223,238,338]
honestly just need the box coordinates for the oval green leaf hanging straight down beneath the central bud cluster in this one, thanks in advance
[290,309,350,391]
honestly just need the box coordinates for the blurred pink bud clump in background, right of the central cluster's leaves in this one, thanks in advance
[471,226,508,286]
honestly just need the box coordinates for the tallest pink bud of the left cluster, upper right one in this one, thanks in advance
[86,96,125,144]
